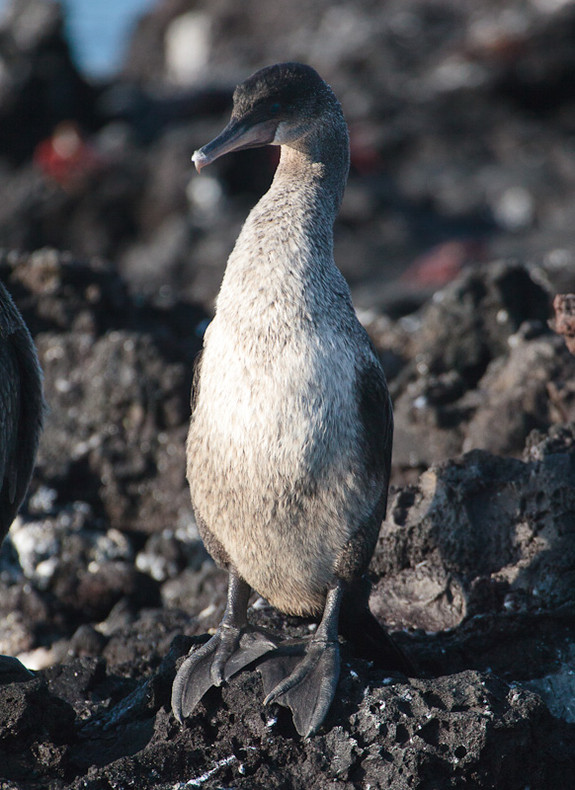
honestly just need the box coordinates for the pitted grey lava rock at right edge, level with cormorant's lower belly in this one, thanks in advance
[372,430,575,631]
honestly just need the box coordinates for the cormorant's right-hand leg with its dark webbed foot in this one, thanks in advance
[258,581,343,738]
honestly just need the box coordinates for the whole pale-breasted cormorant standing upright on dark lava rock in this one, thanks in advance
[173,64,410,735]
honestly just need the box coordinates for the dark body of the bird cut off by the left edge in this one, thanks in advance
[0,283,44,540]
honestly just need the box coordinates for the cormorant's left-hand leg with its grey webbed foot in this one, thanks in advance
[172,571,277,724]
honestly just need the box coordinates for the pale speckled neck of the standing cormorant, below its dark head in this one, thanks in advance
[217,96,349,322]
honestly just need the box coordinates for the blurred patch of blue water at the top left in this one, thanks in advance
[0,0,157,79]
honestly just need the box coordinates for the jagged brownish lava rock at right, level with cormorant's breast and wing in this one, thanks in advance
[388,261,575,469]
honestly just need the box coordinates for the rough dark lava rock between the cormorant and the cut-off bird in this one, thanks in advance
[0,250,205,532]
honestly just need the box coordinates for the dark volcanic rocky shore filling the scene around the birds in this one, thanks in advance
[0,0,575,790]
